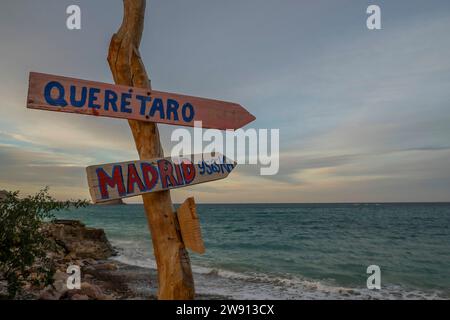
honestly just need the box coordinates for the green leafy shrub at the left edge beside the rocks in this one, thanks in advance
[0,188,88,298]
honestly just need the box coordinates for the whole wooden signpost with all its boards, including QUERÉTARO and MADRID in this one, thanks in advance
[27,0,255,300]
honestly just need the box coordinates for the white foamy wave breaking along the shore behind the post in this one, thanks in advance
[113,241,448,300]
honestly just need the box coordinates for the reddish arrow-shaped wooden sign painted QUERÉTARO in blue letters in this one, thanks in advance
[27,72,255,130]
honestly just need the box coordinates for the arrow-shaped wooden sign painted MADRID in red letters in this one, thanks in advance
[86,153,236,203]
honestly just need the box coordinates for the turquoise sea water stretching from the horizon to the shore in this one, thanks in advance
[59,204,450,299]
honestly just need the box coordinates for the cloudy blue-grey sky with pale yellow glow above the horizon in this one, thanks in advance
[0,0,450,203]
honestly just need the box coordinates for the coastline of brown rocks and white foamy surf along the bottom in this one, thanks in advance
[0,215,448,300]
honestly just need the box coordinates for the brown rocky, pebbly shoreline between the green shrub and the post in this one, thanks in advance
[0,220,225,300]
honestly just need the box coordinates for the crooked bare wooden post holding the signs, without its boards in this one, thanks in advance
[108,0,195,300]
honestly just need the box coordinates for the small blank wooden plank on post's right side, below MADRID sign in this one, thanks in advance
[177,198,205,254]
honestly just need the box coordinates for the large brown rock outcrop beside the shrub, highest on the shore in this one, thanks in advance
[44,220,115,262]
